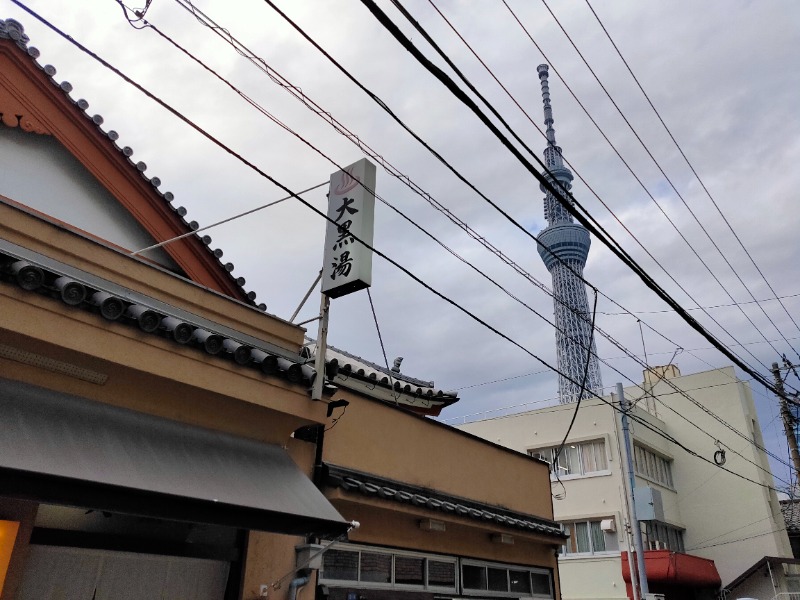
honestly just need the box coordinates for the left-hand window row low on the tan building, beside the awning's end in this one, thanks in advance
[319,546,457,593]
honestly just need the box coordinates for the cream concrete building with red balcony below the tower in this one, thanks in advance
[460,365,797,600]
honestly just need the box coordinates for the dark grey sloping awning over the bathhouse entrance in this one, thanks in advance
[0,379,348,535]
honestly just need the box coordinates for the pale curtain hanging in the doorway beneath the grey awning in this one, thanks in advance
[19,546,230,600]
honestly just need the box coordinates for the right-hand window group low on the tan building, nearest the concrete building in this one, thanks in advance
[461,559,553,598]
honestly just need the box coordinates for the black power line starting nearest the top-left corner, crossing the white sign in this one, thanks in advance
[12,0,775,496]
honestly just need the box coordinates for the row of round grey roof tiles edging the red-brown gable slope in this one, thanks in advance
[0,19,260,310]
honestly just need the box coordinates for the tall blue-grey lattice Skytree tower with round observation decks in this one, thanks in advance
[536,65,603,404]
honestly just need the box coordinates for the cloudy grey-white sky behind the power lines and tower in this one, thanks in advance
[6,0,800,486]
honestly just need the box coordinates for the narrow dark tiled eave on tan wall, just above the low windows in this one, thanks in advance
[324,464,569,539]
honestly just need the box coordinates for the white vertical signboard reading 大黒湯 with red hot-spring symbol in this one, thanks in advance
[322,158,375,298]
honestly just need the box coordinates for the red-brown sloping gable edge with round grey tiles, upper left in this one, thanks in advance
[0,19,255,304]
